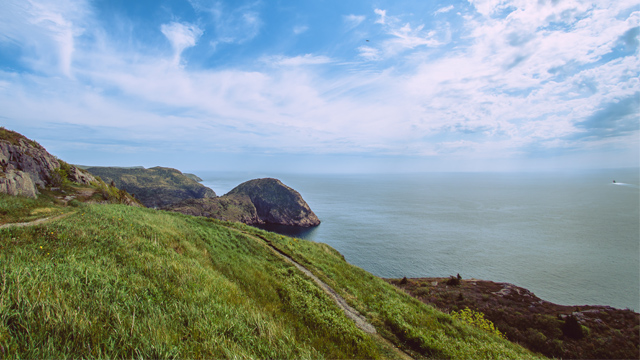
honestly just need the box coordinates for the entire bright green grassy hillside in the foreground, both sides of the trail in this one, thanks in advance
[0,195,544,358]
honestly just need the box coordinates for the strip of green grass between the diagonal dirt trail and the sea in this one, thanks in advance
[228,224,538,359]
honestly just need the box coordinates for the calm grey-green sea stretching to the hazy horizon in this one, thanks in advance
[198,169,640,311]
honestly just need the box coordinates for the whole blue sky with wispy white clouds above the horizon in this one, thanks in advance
[0,0,640,172]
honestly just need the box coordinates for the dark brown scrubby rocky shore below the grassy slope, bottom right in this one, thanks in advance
[386,277,640,359]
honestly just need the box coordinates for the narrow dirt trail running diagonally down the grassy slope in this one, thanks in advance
[225,226,413,360]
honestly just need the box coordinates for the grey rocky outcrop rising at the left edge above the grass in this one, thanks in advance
[0,128,95,197]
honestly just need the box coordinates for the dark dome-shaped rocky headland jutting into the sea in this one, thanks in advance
[225,178,320,227]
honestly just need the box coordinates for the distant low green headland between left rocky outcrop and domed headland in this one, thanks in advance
[87,167,216,208]
